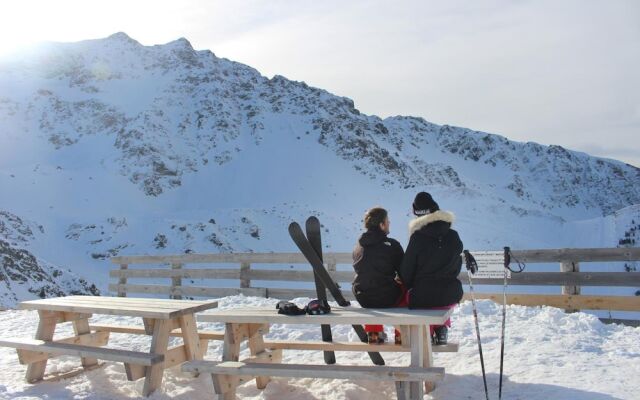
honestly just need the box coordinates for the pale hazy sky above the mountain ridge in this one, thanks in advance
[0,0,640,166]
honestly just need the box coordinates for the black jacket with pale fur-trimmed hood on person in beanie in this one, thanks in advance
[400,210,463,308]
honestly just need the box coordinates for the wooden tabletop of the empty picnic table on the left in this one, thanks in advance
[18,296,218,319]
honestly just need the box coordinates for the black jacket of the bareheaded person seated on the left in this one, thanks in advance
[352,229,404,308]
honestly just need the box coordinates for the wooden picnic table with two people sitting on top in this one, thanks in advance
[182,307,457,400]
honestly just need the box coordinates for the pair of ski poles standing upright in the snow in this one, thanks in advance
[463,247,524,400]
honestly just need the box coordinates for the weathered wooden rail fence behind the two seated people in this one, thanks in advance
[109,248,640,324]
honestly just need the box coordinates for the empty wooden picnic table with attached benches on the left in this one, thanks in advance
[0,296,218,396]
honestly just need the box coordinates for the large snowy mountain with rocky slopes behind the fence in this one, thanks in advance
[0,33,640,306]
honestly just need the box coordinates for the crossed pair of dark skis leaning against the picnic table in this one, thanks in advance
[289,216,384,365]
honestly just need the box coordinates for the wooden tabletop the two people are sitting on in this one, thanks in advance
[197,307,453,325]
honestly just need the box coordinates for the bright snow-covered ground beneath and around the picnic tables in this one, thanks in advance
[0,296,640,400]
